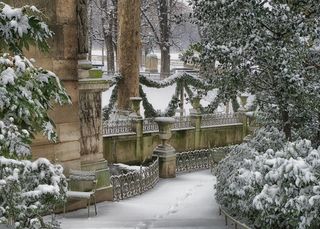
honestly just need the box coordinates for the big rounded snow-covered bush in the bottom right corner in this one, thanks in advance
[216,128,320,228]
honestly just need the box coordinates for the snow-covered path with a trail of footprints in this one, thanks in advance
[58,171,226,229]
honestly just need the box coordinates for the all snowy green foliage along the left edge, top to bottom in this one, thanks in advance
[0,2,70,228]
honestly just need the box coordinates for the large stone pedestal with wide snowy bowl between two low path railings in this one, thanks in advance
[153,117,177,178]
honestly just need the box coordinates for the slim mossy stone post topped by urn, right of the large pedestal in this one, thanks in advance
[190,97,202,149]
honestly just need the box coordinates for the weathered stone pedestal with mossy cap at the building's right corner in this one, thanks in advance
[79,77,112,201]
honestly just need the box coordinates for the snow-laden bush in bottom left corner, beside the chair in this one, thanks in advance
[0,156,67,228]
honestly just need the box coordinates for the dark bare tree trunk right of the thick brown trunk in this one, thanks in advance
[158,0,170,78]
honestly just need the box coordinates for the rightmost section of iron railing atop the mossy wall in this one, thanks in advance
[201,113,242,127]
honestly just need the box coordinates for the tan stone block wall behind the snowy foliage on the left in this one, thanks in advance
[6,0,80,172]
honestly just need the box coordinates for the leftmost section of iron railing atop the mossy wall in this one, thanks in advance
[103,119,134,135]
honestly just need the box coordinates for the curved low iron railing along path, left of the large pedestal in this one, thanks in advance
[111,158,159,201]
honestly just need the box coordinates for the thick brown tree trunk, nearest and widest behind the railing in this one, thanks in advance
[117,0,141,110]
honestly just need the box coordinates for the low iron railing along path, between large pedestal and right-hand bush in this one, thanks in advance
[176,146,233,172]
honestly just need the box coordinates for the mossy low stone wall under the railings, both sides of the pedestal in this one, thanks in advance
[103,124,244,164]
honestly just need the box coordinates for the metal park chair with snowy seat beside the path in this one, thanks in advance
[63,169,97,217]
